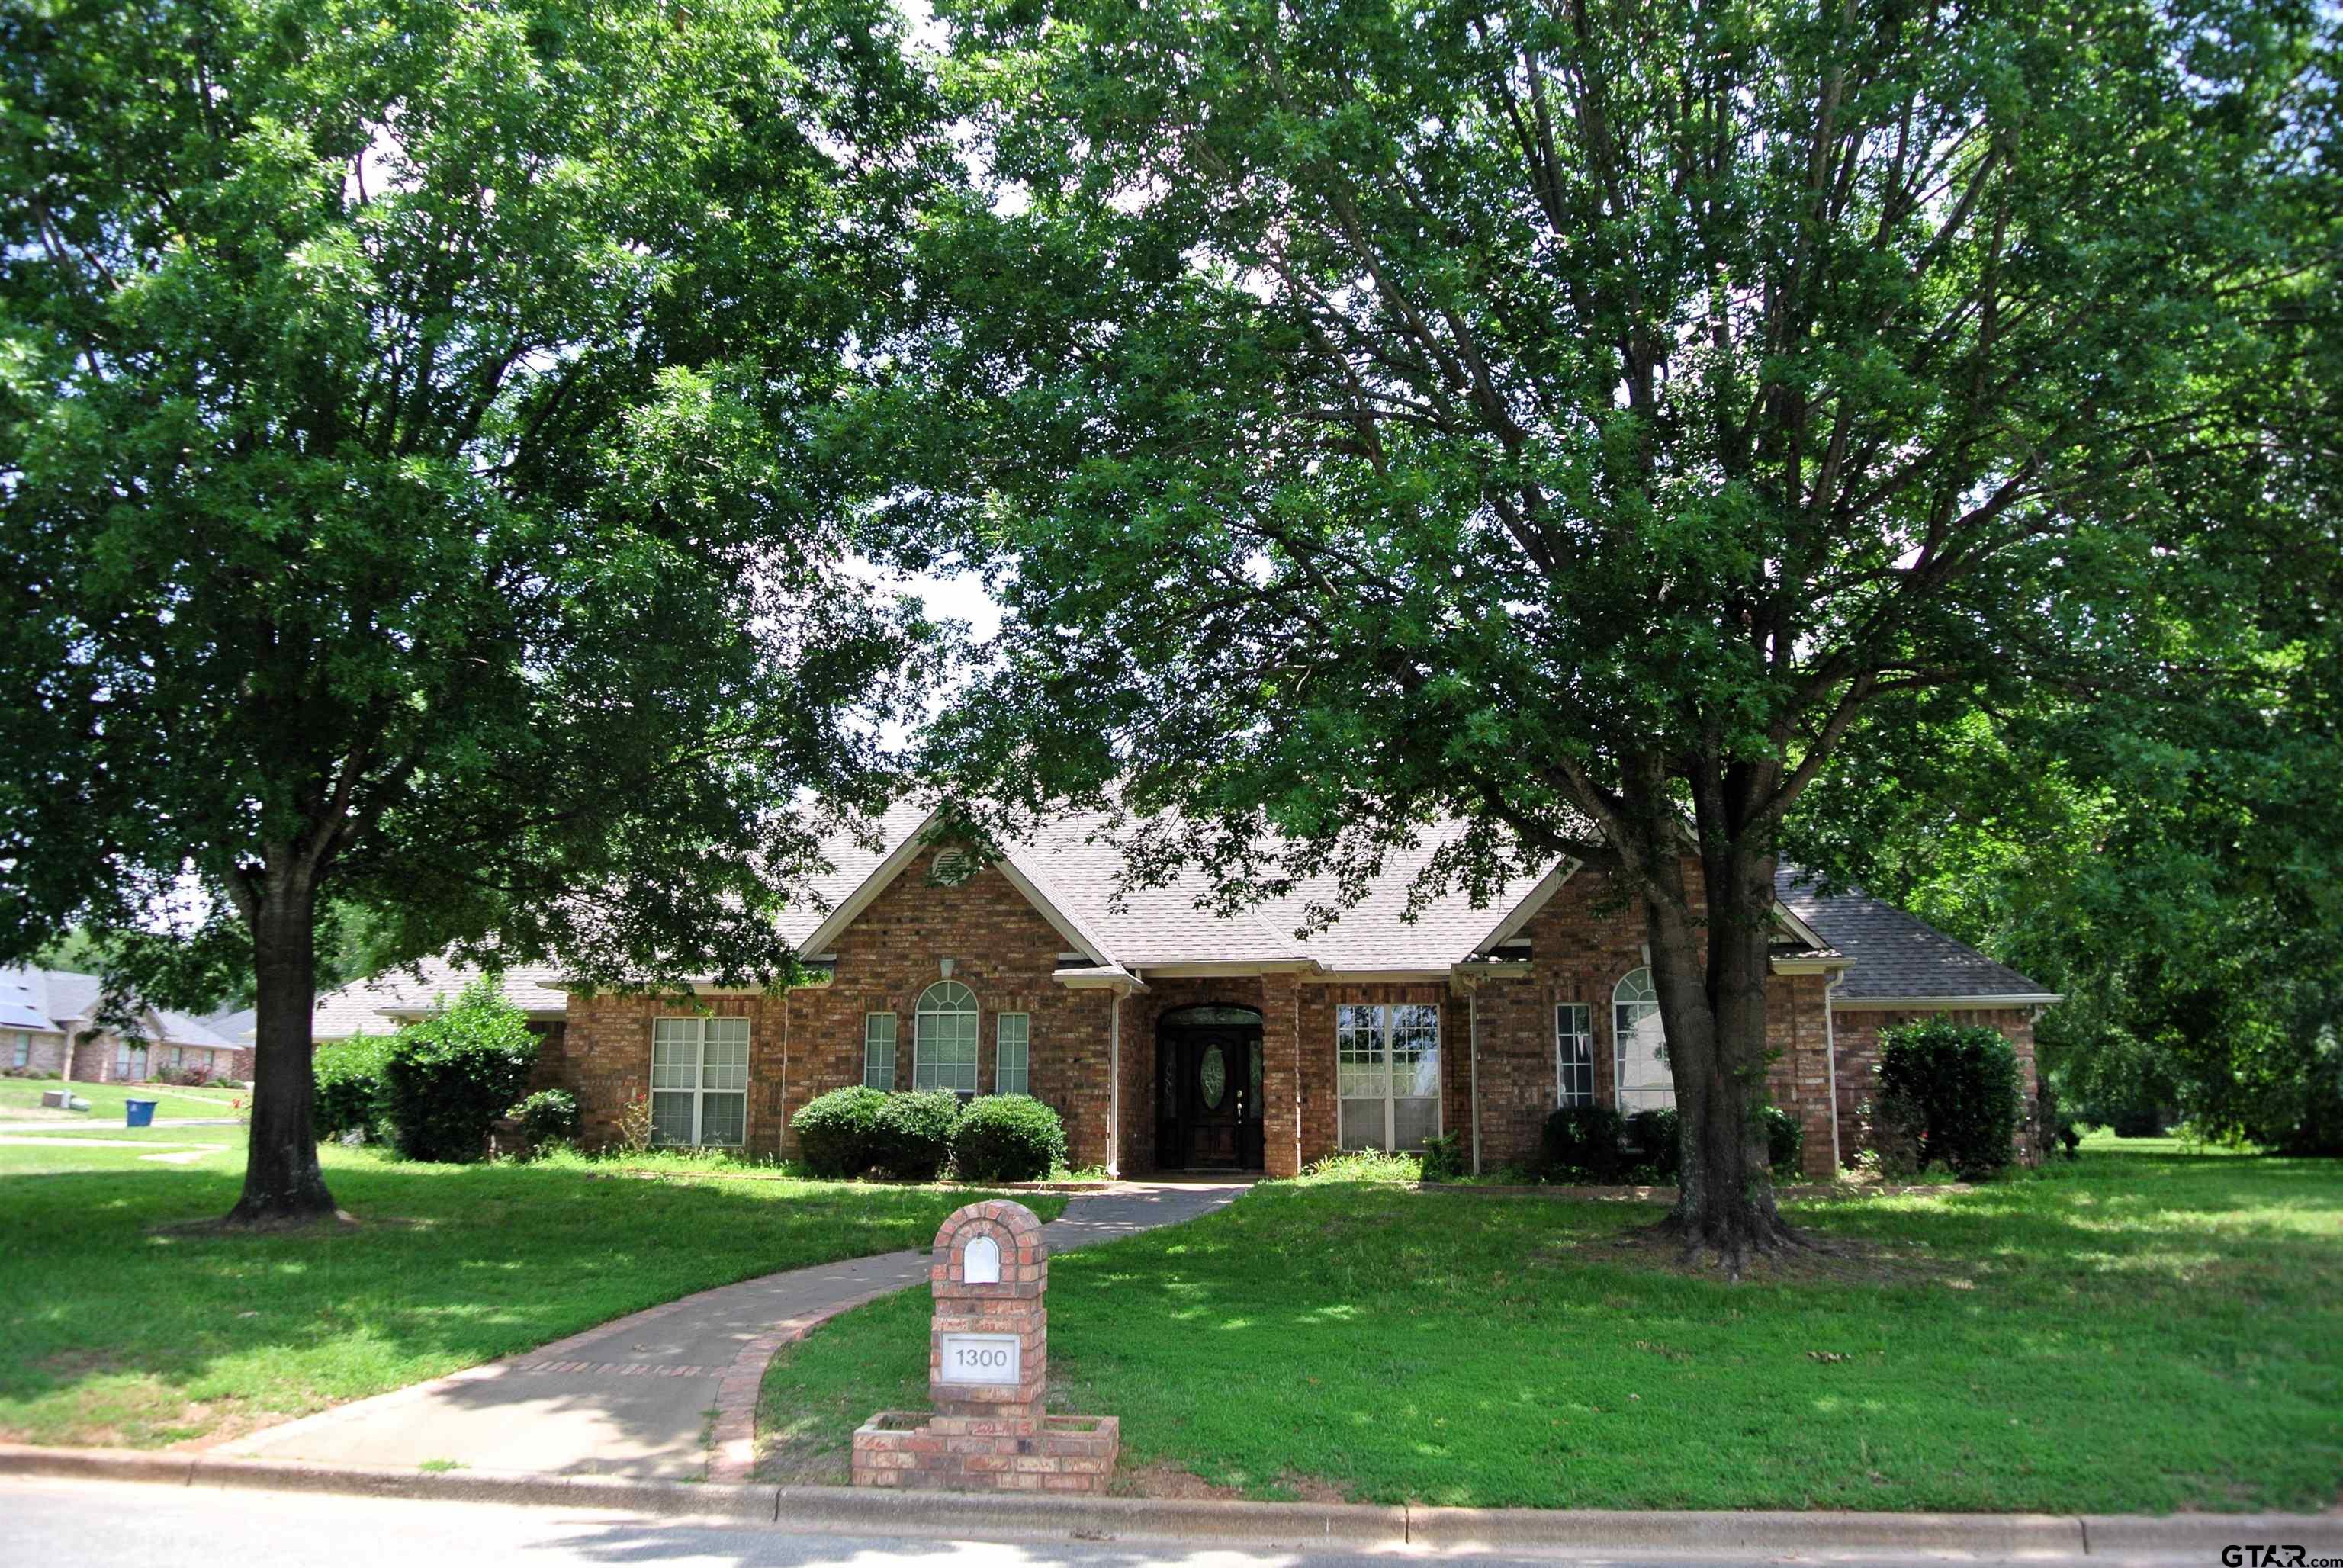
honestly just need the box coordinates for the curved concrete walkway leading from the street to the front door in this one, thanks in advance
[220,1181,1244,1481]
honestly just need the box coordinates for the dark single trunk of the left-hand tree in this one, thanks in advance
[227,869,335,1228]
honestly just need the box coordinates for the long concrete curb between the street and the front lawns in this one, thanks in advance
[0,1444,2343,1557]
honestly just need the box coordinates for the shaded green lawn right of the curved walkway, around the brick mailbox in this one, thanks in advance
[759,1144,2343,1512]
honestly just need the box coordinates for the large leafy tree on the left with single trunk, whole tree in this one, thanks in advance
[0,0,937,1223]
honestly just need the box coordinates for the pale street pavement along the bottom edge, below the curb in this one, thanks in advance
[0,1476,2277,1568]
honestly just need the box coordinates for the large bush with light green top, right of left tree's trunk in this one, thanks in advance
[382,975,536,1160]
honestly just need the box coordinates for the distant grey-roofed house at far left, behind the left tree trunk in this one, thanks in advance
[0,968,253,1083]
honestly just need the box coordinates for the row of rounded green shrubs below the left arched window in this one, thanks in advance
[789,1085,1066,1181]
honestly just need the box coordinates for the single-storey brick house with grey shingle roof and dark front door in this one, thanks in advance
[319,811,2057,1177]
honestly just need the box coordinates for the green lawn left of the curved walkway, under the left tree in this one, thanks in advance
[0,1125,1064,1446]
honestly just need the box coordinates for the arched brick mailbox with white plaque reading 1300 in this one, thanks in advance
[853,1197,1122,1493]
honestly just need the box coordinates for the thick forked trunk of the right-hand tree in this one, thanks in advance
[1645,851,1797,1271]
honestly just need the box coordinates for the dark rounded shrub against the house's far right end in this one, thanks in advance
[1872,1017,2024,1181]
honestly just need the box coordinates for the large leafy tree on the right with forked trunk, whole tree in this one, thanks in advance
[905,0,2334,1258]
